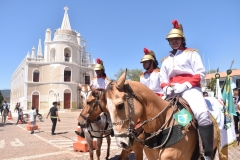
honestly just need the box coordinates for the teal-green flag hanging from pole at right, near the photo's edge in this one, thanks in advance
[222,71,237,116]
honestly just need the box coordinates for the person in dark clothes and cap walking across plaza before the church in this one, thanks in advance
[46,102,60,135]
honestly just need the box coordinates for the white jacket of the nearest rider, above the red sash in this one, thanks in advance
[160,49,205,88]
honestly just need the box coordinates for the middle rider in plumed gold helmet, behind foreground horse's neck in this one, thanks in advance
[140,48,164,98]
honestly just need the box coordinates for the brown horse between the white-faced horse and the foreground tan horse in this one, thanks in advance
[78,84,143,160]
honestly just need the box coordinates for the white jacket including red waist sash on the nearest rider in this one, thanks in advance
[160,49,205,88]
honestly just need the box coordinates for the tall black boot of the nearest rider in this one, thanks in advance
[199,124,214,160]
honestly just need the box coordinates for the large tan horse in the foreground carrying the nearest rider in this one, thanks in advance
[88,72,217,160]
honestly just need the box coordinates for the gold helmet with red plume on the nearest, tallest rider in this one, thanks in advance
[166,20,185,40]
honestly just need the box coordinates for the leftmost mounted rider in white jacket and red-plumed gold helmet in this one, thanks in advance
[75,58,109,137]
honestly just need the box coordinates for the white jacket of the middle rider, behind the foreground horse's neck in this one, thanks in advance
[140,69,163,94]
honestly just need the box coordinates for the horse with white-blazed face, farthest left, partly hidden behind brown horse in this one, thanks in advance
[79,84,111,160]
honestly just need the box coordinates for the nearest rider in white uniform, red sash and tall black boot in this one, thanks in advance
[160,20,214,160]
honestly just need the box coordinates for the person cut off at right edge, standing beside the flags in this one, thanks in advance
[233,88,240,134]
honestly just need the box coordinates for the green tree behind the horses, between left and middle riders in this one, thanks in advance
[114,68,142,82]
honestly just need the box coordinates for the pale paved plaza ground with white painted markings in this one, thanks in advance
[0,111,240,160]
